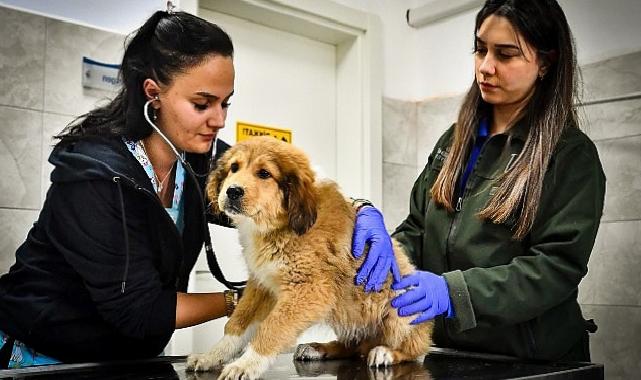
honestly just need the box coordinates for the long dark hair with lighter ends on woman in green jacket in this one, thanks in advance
[431,0,579,240]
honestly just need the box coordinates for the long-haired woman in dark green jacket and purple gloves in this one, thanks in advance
[354,0,605,361]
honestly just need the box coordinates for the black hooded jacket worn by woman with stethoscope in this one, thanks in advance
[0,138,228,362]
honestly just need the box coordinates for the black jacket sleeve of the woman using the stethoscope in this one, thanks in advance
[46,180,176,339]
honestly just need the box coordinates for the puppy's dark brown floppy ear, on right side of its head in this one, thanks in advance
[284,170,316,235]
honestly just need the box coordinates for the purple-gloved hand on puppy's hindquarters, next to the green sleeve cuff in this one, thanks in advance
[392,271,454,325]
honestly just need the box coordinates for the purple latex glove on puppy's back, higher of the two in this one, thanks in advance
[352,206,401,292]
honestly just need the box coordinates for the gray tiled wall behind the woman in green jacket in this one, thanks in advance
[383,52,641,379]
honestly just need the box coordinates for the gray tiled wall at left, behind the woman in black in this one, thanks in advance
[0,7,124,273]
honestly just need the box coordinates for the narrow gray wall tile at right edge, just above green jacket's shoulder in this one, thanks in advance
[579,99,641,140]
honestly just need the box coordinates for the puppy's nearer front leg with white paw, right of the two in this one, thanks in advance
[219,285,331,380]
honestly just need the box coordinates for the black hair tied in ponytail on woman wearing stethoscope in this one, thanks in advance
[56,11,234,144]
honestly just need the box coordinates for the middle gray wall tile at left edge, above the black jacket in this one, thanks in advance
[0,106,42,209]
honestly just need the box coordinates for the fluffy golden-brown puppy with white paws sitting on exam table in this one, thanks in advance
[187,137,432,379]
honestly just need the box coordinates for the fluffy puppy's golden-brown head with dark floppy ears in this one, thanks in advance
[207,137,316,234]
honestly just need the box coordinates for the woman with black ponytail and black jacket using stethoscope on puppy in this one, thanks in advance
[0,9,240,368]
